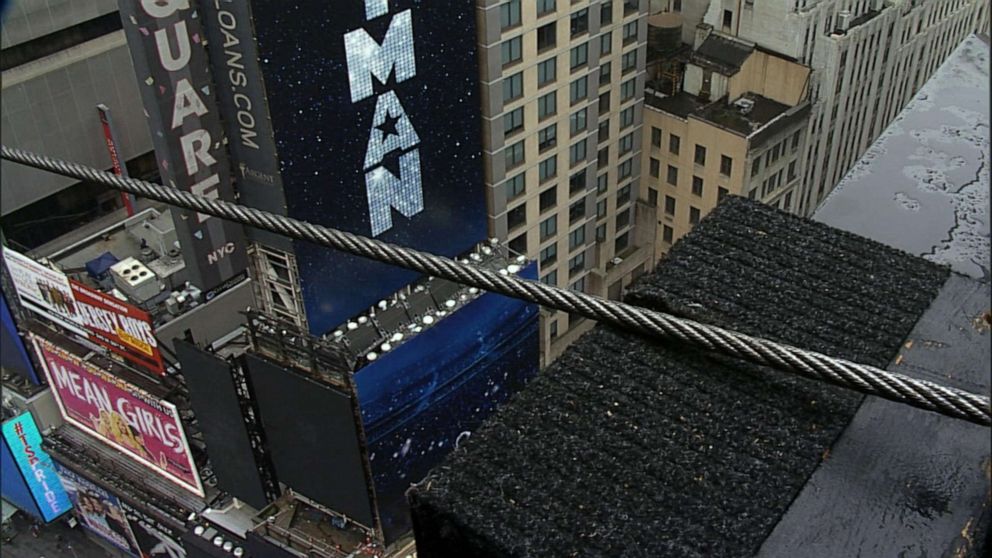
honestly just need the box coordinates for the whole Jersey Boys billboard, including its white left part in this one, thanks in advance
[3,249,165,376]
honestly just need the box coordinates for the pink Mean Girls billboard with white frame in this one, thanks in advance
[31,335,204,496]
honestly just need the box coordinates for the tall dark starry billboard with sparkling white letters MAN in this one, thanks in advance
[252,0,486,334]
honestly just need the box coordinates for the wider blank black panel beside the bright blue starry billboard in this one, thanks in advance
[245,354,373,527]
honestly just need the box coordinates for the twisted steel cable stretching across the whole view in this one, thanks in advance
[0,146,992,426]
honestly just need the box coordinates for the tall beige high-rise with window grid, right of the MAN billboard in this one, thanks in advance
[477,0,654,363]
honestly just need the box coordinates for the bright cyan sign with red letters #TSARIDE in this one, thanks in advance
[3,412,72,521]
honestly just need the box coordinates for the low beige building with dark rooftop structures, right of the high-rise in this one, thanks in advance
[641,27,810,258]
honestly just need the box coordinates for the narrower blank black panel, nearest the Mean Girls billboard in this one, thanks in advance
[175,339,268,509]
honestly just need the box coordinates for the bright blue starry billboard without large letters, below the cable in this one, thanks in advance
[355,264,540,542]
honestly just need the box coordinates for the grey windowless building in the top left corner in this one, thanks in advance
[0,0,155,250]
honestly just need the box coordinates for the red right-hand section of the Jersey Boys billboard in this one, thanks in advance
[69,279,165,376]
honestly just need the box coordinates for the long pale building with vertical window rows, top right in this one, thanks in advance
[652,0,989,223]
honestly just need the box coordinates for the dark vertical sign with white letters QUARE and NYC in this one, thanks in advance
[117,0,248,300]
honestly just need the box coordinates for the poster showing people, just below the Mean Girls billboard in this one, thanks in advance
[56,463,140,556]
